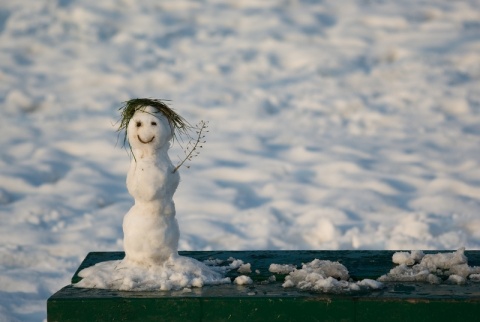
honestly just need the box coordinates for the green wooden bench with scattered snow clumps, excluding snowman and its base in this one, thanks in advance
[47,249,480,322]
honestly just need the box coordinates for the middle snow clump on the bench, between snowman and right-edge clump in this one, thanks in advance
[282,259,383,293]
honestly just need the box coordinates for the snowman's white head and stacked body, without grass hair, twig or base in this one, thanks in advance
[123,107,180,266]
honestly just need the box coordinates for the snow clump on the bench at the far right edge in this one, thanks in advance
[378,248,480,284]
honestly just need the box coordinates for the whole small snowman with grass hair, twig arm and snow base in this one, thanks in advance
[74,98,231,291]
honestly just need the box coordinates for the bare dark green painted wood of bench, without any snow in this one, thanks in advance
[47,251,480,322]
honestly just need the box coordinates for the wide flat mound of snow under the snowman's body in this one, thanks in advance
[73,255,231,291]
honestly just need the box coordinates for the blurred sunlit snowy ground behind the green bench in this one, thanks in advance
[0,0,480,321]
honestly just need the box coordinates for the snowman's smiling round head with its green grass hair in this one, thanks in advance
[118,98,190,157]
